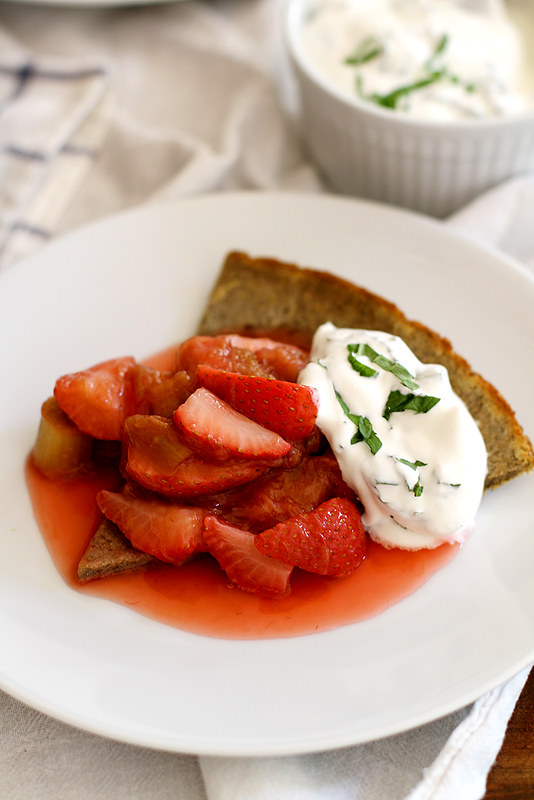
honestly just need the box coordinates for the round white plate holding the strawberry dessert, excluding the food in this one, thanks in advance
[0,193,534,755]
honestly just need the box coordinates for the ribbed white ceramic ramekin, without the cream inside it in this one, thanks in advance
[285,0,534,217]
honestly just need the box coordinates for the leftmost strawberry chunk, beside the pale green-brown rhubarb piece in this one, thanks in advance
[54,357,135,441]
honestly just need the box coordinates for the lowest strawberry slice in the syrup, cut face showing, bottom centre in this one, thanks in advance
[204,516,293,597]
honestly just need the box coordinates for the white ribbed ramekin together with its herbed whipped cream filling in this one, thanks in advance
[286,0,534,217]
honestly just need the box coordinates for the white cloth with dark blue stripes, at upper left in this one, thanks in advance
[0,31,110,270]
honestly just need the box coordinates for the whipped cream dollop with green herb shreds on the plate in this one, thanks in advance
[299,323,487,550]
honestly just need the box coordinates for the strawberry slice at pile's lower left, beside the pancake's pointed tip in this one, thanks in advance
[96,489,206,566]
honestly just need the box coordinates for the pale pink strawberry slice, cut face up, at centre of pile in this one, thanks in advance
[173,386,291,459]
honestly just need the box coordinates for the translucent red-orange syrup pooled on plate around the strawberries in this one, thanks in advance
[26,344,458,639]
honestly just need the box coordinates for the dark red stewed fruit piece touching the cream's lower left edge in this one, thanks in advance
[211,455,354,533]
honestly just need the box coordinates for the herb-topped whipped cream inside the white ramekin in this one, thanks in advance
[300,0,533,121]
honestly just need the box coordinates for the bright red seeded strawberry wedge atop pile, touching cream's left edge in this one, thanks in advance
[198,364,317,440]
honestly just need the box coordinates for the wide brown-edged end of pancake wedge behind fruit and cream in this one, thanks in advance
[198,251,534,488]
